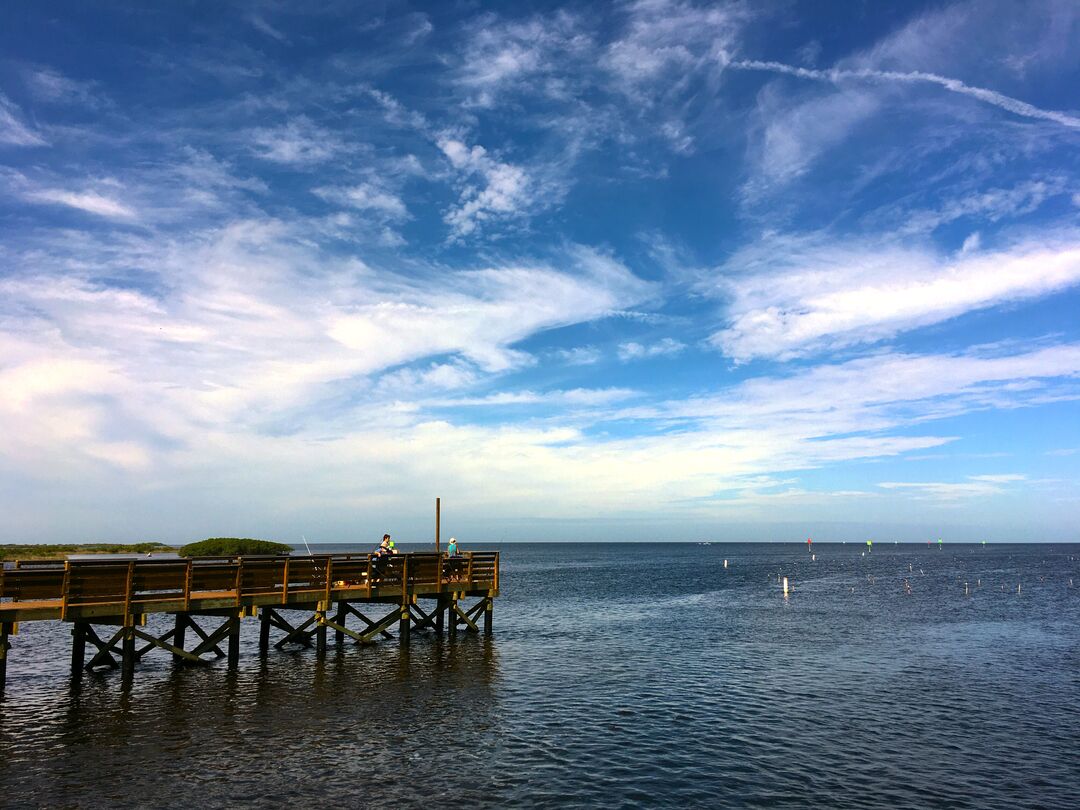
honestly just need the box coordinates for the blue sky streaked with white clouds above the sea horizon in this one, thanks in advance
[0,0,1080,548]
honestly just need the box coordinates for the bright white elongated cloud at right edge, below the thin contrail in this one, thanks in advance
[712,235,1080,361]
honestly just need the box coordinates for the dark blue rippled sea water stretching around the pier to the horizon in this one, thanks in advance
[0,543,1080,808]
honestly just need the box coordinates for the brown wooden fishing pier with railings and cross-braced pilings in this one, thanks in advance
[0,552,499,692]
